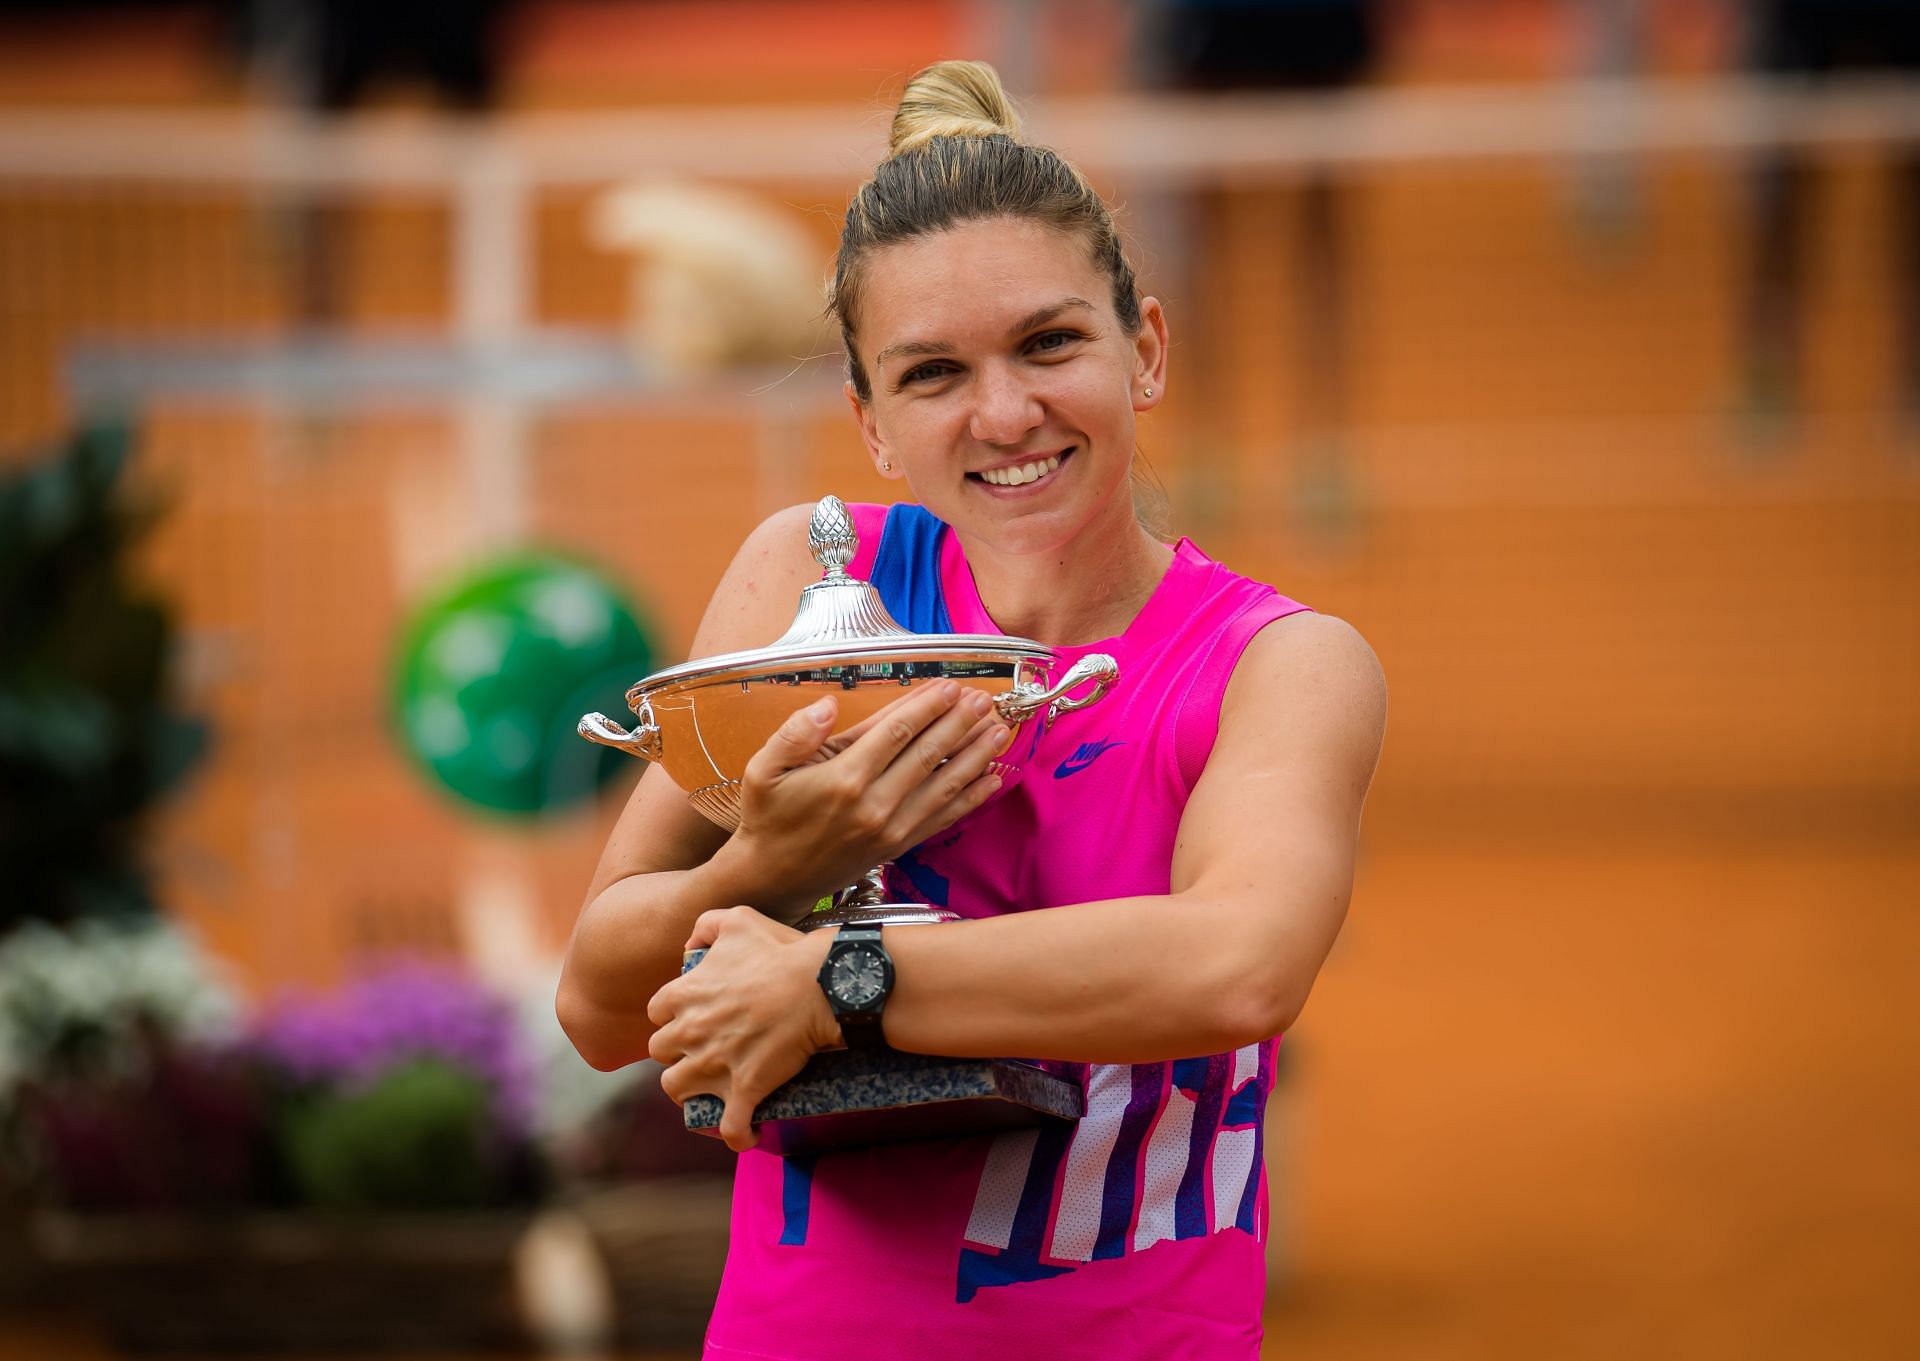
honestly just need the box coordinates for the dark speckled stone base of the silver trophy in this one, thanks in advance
[684,1048,1087,1154]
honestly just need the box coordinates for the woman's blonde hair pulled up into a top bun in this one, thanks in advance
[828,61,1140,401]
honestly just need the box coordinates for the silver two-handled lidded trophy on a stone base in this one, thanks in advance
[580,495,1119,1152]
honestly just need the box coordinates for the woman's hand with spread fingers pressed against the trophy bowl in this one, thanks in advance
[716,680,1012,923]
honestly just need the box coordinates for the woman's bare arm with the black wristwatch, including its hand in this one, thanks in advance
[649,614,1386,1146]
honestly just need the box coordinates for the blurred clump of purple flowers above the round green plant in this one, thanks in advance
[252,956,534,1140]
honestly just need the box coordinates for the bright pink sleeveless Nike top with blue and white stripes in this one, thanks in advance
[707,505,1308,1361]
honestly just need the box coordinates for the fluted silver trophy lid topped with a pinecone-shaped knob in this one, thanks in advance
[628,495,1054,706]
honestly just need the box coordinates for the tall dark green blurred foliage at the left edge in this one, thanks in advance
[0,428,207,935]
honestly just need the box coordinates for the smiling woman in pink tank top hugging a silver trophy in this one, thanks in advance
[559,61,1386,1361]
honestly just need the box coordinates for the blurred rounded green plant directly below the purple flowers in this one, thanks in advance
[282,1060,503,1211]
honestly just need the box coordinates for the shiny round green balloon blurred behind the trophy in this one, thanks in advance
[394,553,655,816]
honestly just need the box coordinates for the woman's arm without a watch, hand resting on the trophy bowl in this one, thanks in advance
[555,507,1010,1069]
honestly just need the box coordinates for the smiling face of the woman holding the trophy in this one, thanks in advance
[847,219,1167,553]
